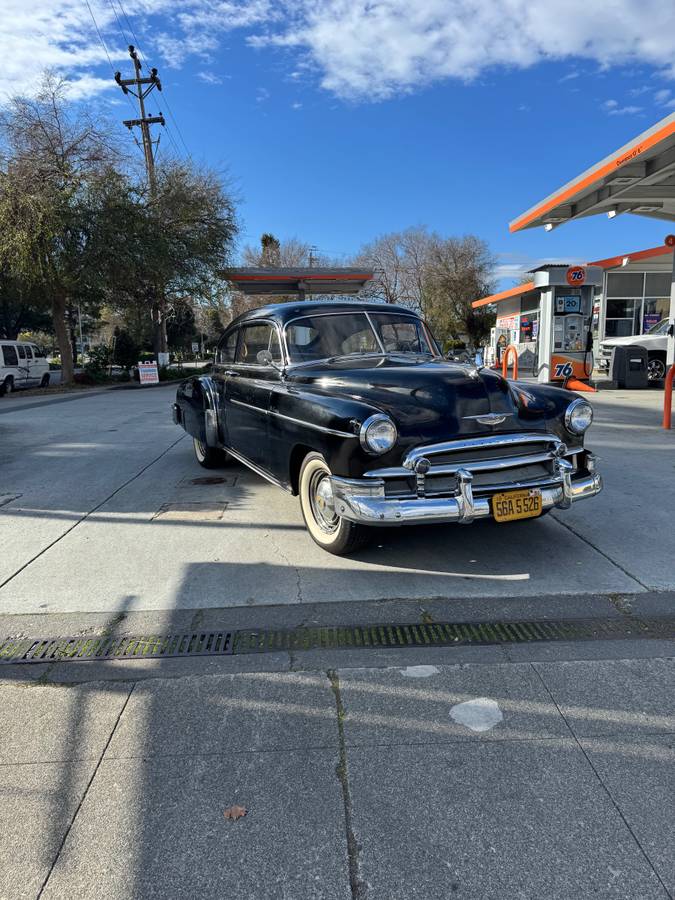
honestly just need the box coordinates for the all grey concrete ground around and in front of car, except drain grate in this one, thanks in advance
[0,388,675,900]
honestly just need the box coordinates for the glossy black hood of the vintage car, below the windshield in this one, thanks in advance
[288,354,545,439]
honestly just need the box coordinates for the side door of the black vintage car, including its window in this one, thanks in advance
[222,320,282,471]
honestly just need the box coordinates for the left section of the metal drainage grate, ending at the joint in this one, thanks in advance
[0,631,232,663]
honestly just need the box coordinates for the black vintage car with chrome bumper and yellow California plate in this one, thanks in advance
[173,301,602,554]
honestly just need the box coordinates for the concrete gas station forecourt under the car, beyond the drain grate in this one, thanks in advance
[0,387,675,614]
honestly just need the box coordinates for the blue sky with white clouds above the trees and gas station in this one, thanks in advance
[6,0,675,286]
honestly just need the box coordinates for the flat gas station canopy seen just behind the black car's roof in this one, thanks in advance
[221,266,374,300]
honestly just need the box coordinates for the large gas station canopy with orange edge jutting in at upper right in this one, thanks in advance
[509,113,675,232]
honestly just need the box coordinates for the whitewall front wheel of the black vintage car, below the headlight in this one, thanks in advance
[299,453,370,556]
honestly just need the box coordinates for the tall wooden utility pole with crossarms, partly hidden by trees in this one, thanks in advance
[115,44,168,356]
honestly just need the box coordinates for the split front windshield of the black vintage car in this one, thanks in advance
[286,312,432,363]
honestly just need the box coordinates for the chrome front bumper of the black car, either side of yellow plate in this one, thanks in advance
[331,470,602,525]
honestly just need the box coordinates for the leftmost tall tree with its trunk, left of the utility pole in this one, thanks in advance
[0,73,119,383]
